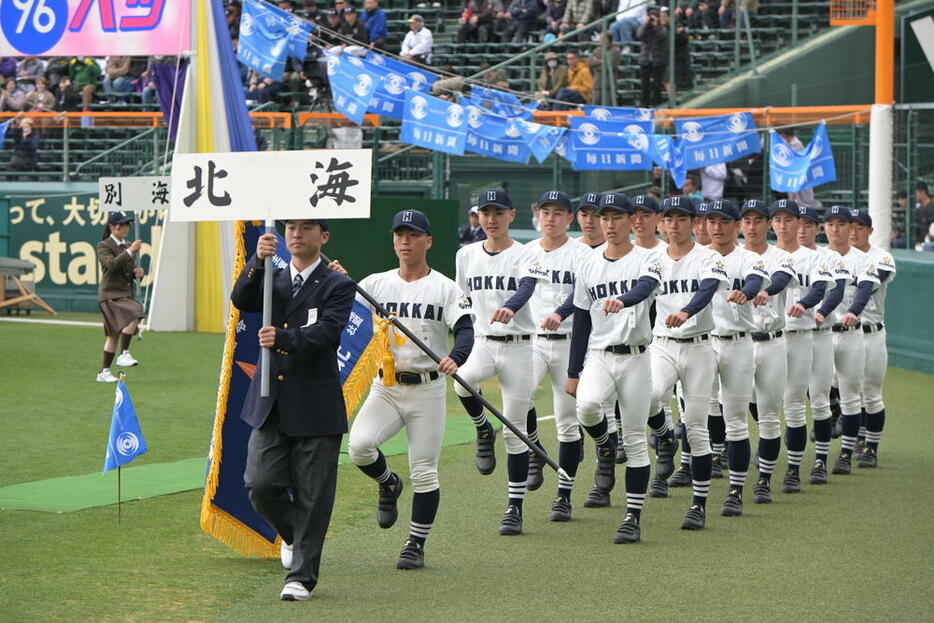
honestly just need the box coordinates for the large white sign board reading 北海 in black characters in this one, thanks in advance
[169,149,373,221]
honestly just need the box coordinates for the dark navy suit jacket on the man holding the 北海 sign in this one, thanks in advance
[230,256,356,437]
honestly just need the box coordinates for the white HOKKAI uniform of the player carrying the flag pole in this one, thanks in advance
[348,269,473,493]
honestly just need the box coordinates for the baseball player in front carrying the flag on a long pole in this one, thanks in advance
[348,210,473,569]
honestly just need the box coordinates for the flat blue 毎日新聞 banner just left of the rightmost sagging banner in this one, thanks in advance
[675,112,762,170]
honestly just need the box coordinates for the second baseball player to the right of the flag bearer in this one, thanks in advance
[525,190,593,521]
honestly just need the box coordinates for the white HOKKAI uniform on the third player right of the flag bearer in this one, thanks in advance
[574,247,661,467]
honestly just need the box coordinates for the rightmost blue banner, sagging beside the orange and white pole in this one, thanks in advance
[769,123,837,193]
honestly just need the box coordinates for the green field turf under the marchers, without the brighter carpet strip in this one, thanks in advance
[0,323,934,622]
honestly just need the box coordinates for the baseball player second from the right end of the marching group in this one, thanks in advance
[819,205,881,474]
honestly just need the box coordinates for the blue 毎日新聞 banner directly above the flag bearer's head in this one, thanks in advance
[399,89,467,156]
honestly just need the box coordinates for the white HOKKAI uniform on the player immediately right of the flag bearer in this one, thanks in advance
[454,241,535,454]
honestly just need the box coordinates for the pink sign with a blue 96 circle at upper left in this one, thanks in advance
[0,0,191,56]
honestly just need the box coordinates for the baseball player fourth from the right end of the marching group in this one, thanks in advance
[772,199,834,493]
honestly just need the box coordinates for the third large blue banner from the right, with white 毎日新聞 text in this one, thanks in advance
[570,117,652,171]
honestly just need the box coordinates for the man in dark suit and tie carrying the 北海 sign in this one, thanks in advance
[230,220,355,601]
